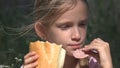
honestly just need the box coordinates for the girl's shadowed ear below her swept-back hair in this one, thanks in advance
[34,22,46,39]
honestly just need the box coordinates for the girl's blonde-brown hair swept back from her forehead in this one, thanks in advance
[34,0,87,26]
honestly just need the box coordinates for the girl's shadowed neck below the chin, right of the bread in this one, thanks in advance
[63,55,79,68]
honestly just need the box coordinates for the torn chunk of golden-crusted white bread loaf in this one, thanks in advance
[29,41,66,68]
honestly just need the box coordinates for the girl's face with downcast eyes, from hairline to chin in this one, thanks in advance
[47,1,88,55]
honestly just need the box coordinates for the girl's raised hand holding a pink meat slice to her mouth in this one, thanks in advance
[83,38,112,68]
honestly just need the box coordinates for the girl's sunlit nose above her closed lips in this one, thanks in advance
[71,28,81,41]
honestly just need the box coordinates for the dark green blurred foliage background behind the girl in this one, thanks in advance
[0,0,120,68]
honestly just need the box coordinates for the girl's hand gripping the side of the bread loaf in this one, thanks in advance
[23,52,39,68]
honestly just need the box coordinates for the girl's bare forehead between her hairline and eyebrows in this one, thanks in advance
[56,0,88,22]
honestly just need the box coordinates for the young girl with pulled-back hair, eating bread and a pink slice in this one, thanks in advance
[23,0,112,68]
